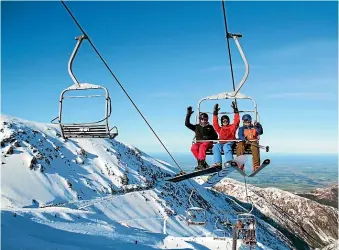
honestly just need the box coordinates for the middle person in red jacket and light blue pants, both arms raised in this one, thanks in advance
[213,102,240,166]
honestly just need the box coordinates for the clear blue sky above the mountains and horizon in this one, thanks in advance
[1,2,338,153]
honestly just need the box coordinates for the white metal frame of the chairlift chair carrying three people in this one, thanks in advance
[193,33,269,155]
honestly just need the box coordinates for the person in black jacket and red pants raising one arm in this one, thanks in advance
[185,106,218,170]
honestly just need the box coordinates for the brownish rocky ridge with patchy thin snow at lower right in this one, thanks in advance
[214,179,339,248]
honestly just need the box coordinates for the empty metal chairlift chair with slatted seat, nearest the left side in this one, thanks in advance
[51,35,118,139]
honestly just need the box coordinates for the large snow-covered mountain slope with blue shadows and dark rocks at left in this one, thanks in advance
[0,115,310,249]
